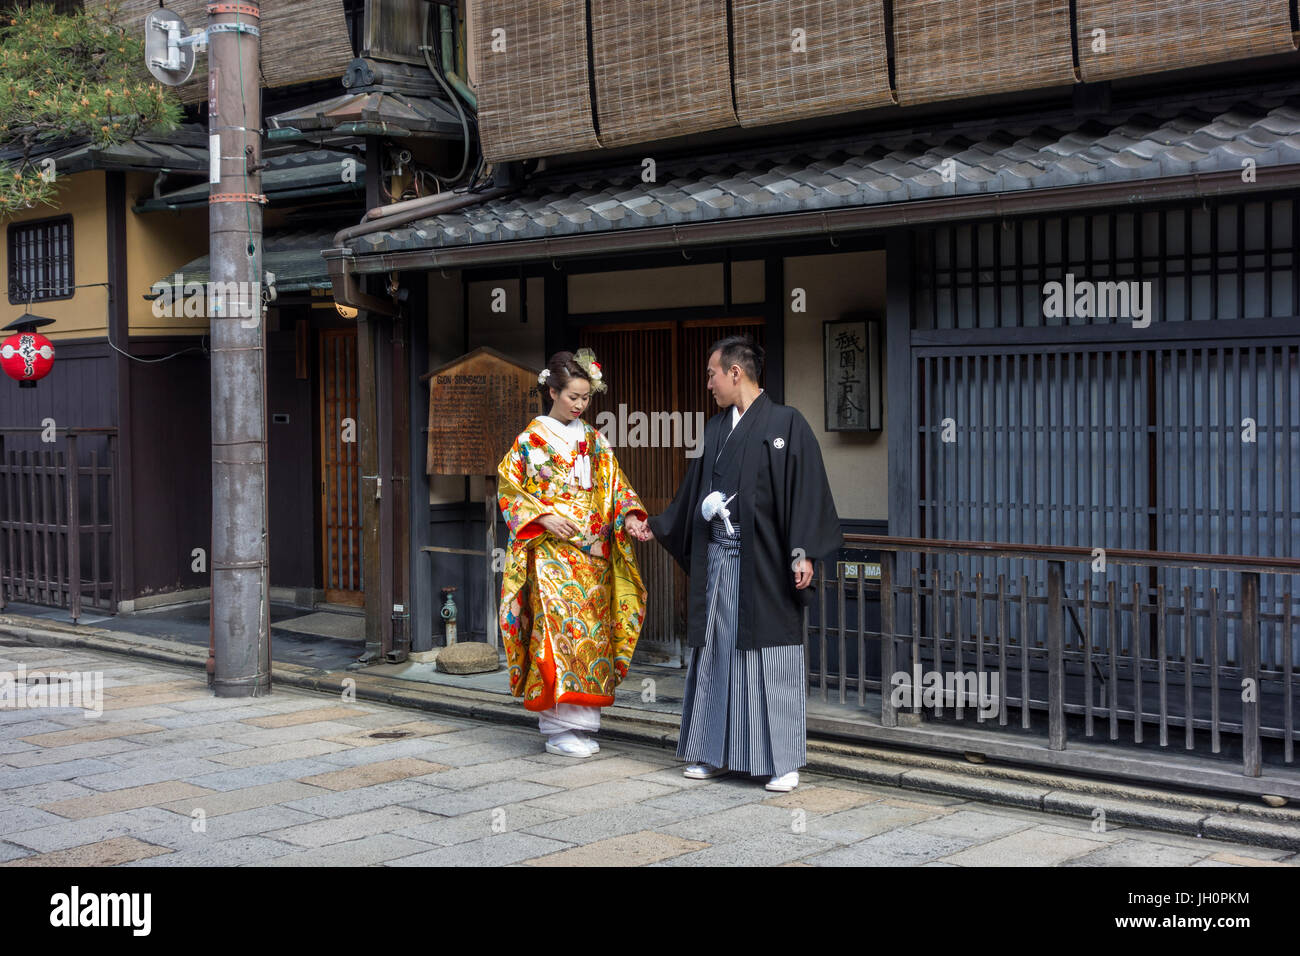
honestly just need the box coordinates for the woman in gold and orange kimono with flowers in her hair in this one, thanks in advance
[497,349,646,757]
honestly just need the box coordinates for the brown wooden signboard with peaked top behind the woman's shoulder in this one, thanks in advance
[421,346,542,475]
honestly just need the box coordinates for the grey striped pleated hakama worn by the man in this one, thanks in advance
[677,518,807,777]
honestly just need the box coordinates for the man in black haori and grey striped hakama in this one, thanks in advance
[631,336,844,791]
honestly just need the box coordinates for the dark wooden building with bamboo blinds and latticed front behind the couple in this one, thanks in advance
[325,0,1300,793]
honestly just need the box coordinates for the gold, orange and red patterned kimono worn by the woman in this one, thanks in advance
[497,418,646,710]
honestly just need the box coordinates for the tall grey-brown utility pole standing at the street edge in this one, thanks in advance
[208,1,270,697]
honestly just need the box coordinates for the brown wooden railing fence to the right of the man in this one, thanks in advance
[803,535,1300,777]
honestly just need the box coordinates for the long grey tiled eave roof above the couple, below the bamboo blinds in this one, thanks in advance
[352,94,1300,254]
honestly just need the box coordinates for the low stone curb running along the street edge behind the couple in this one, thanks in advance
[0,615,1300,851]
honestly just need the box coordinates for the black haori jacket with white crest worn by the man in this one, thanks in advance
[650,392,844,650]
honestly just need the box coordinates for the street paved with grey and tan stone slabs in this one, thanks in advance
[0,645,1297,866]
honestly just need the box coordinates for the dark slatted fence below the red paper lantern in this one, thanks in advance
[0,427,117,622]
